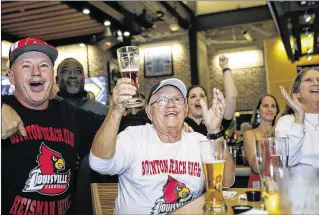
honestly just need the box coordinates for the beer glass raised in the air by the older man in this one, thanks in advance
[117,46,144,108]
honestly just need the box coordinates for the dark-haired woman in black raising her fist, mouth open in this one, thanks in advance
[185,55,238,135]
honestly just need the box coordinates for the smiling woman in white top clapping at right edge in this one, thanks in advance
[275,67,319,169]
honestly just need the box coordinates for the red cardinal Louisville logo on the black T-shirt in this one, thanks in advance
[22,143,70,196]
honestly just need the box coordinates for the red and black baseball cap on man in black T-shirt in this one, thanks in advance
[9,37,58,65]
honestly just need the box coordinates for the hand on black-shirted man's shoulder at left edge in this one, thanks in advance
[1,104,27,139]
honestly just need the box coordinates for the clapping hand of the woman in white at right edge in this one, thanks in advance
[279,86,305,123]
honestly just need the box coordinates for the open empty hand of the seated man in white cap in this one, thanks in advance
[199,88,226,133]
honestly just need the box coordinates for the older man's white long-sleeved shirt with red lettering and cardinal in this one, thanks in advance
[90,124,207,214]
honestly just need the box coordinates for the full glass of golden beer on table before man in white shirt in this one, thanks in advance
[200,140,227,212]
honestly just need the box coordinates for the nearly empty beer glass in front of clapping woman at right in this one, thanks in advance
[255,137,288,214]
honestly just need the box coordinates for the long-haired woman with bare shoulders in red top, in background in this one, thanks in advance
[244,94,280,188]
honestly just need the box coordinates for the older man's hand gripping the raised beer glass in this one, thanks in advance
[112,78,137,114]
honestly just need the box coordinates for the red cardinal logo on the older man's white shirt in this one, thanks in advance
[151,176,194,214]
